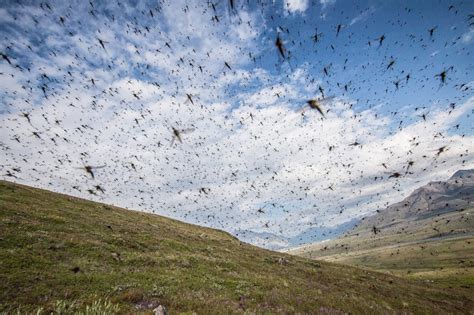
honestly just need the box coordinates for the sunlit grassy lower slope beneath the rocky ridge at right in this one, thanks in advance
[289,209,474,296]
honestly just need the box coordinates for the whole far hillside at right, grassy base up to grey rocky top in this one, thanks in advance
[288,170,474,292]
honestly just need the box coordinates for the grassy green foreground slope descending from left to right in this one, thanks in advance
[0,181,474,314]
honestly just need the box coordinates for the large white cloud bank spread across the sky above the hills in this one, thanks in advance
[0,1,474,251]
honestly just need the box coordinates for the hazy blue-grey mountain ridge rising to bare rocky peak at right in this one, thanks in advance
[248,170,474,250]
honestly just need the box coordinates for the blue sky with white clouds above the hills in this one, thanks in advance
[0,0,474,248]
